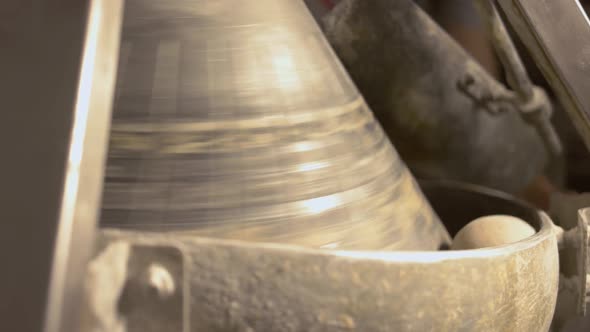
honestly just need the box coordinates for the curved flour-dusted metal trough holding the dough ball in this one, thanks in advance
[91,184,558,332]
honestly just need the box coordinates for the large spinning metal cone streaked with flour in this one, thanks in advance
[102,0,449,250]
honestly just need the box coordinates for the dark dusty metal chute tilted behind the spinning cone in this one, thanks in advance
[324,0,545,192]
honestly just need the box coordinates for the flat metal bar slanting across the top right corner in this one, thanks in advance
[498,0,590,152]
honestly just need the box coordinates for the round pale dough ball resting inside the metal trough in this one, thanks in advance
[451,215,535,250]
